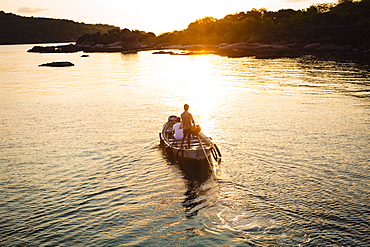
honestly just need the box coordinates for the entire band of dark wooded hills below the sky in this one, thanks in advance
[0,0,370,48]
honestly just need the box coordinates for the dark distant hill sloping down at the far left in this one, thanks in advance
[0,11,119,44]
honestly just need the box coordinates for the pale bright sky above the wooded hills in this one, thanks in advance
[0,0,337,35]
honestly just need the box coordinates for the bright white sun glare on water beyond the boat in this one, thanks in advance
[162,55,223,133]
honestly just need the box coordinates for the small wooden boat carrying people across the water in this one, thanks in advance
[159,115,221,162]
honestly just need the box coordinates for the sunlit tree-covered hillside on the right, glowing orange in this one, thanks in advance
[157,0,370,47]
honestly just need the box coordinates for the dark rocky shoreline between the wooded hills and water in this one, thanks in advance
[27,42,370,64]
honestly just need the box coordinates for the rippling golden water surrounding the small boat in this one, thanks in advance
[0,45,370,246]
